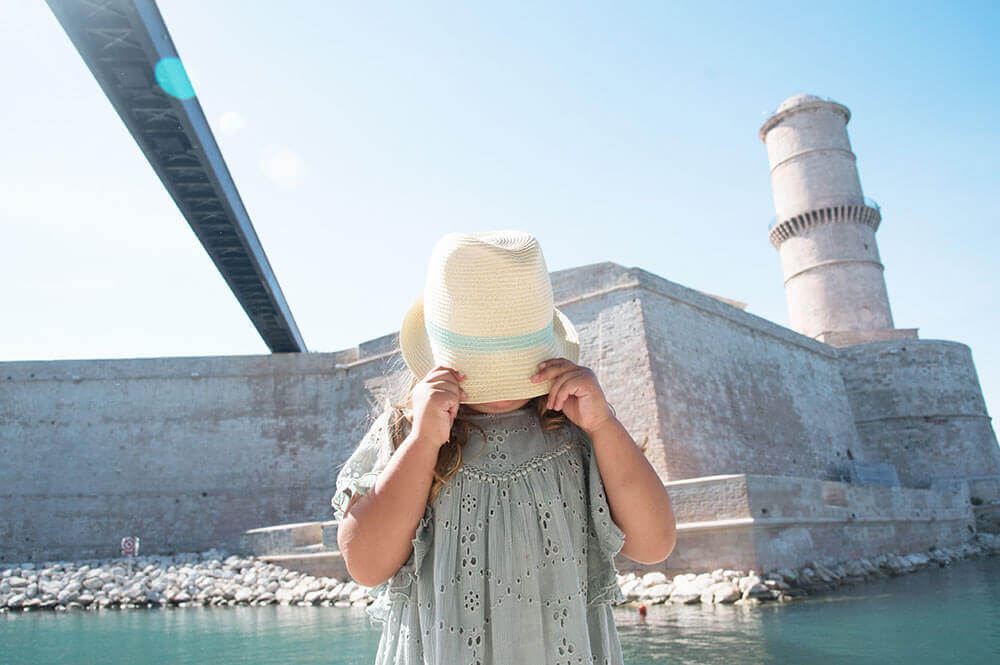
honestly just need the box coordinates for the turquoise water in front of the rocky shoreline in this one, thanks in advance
[0,557,1000,665]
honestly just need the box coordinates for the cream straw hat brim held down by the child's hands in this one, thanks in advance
[399,296,580,404]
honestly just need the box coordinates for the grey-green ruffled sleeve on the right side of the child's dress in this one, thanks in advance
[574,426,626,605]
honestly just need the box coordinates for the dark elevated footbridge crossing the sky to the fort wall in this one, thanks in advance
[47,0,307,353]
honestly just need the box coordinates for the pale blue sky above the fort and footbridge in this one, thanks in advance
[0,0,1000,438]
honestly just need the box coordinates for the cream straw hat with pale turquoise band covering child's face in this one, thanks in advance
[399,230,580,404]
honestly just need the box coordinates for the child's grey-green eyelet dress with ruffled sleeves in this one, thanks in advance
[331,403,625,665]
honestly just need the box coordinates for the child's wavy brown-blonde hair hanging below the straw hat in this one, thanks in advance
[376,344,570,505]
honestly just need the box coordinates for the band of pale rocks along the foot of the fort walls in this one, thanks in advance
[0,534,1000,614]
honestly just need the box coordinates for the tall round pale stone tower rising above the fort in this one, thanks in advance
[760,95,916,346]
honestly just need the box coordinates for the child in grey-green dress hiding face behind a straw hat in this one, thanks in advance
[331,231,675,665]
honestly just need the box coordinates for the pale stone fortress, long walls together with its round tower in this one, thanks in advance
[0,95,1000,574]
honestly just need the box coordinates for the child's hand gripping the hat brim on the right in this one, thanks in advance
[531,358,614,434]
